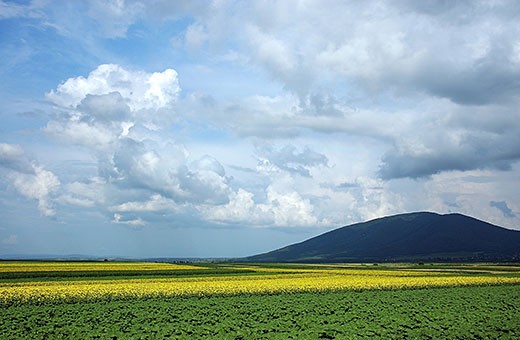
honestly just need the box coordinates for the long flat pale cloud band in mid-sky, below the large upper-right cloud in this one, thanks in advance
[185,94,398,140]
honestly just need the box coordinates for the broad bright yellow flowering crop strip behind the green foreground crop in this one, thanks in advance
[0,264,520,303]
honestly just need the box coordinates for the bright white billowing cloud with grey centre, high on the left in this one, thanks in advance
[45,64,180,153]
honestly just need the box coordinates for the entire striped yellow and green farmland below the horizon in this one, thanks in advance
[0,262,520,339]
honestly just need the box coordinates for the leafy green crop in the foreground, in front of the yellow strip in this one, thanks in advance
[0,286,520,339]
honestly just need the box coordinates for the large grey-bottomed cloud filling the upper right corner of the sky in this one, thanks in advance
[292,2,520,105]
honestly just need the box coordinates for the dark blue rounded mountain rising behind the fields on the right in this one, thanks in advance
[245,212,520,263]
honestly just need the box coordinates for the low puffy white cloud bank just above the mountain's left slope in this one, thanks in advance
[200,174,405,227]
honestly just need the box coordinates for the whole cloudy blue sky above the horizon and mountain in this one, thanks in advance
[0,0,520,258]
